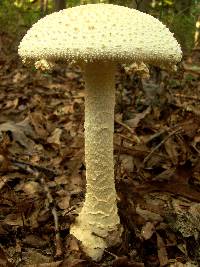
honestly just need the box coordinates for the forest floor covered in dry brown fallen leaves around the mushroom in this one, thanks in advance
[0,34,200,267]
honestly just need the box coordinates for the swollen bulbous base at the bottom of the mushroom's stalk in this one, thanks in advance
[70,215,122,261]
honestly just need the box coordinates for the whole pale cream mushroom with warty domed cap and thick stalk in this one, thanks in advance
[19,4,182,260]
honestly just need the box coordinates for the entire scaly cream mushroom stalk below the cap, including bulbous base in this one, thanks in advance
[70,63,121,261]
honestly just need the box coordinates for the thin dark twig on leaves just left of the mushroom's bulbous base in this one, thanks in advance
[41,177,62,257]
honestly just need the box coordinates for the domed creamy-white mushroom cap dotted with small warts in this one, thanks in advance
[19,4,182,66]
